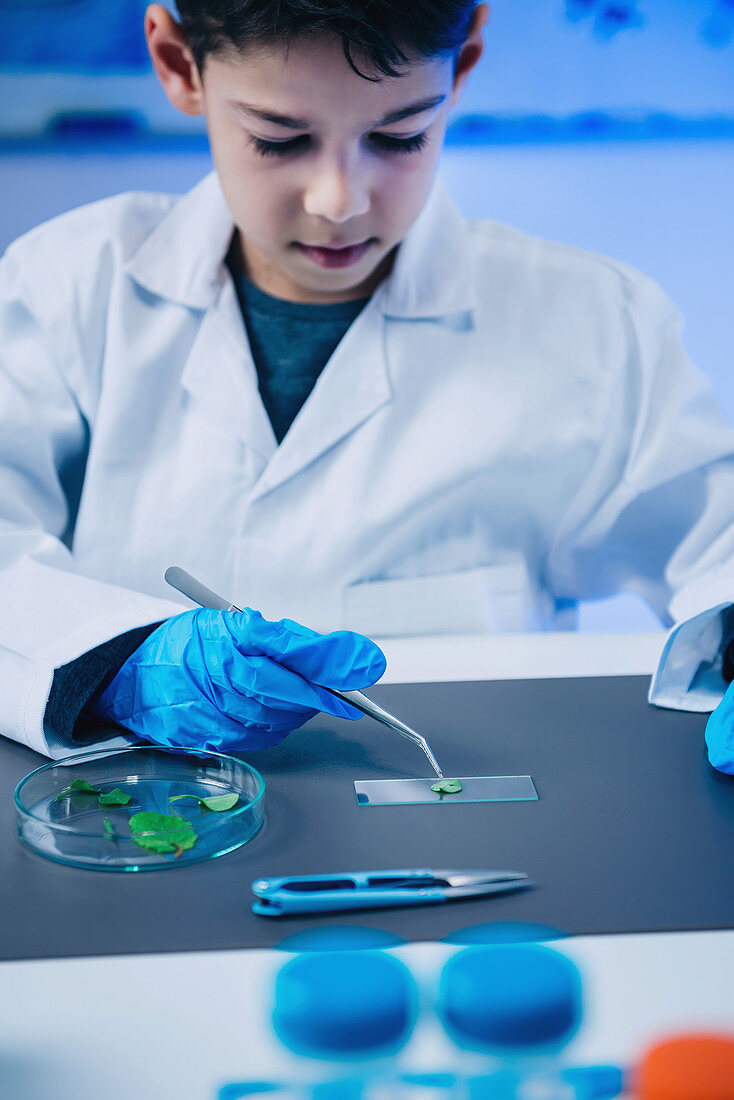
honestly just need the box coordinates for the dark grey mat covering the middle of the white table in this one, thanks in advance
[0,677,734,959]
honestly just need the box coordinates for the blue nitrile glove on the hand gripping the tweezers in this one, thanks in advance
[85,607,386,752]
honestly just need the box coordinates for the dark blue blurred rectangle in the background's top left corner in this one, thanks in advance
[0,0,149,74]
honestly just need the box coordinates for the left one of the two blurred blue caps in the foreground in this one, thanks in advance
[273,952,418,1059]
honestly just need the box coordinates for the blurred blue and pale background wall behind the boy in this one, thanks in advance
[0,0,734,629]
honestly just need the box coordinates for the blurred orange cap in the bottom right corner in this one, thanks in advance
[633,1033,734,1100]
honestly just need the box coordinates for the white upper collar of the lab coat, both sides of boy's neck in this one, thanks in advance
[125,172,475,319]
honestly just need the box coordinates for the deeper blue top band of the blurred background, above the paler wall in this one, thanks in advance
[0,0,734,133]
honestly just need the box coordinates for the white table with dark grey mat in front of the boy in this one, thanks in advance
[0,633,734,1100]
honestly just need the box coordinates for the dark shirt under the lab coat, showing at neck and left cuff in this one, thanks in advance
[44,250,370,743]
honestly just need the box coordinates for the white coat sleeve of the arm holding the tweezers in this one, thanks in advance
[0,248,185,757]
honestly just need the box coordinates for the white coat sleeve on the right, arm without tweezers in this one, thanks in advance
[549,270,734,711]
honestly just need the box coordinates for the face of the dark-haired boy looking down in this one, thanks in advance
[146,9,481,304]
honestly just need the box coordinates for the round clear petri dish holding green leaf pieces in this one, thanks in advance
[13,745,265,871]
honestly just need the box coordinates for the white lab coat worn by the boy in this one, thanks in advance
[0,175,734,756]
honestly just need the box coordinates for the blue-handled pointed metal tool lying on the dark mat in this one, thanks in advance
[252,869,534,916]
